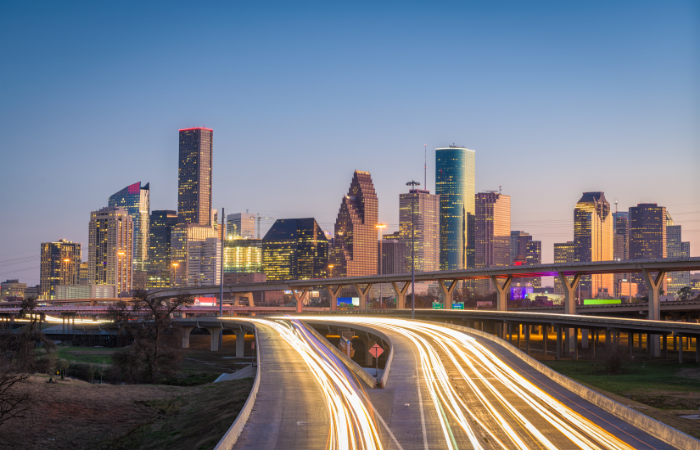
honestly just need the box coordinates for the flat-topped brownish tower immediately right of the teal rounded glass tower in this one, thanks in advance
[474,192,511,294]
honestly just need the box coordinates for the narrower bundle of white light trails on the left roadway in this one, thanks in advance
[237,319,383,450]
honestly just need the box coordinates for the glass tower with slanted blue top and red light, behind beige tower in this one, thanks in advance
[107,181,151,271]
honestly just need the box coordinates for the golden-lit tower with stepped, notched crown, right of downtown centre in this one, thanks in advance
[574,192,615,298]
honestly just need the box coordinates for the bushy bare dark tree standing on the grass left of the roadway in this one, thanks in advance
[110,290,194,383]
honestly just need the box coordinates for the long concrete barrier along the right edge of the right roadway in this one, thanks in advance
[438,322,700,450]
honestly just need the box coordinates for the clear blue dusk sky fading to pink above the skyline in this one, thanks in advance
[0,1,700,285]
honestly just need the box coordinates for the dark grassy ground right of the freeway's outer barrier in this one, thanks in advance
[541,360,700,438]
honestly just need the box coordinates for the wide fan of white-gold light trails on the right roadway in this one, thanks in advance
[297,317,633,450]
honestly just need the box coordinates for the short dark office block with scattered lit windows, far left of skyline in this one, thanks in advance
[39,239,82,300]
